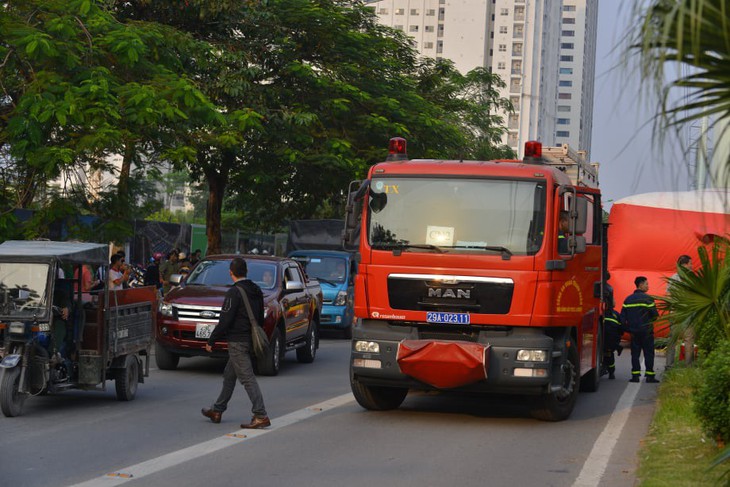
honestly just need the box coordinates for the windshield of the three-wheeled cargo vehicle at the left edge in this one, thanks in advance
[0,262,49,319]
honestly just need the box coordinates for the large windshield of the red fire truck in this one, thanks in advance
[368,177,546,256]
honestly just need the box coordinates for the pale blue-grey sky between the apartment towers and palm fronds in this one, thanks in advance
[589,0,690,209]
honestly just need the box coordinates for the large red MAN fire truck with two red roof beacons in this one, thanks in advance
[344,138,605,421]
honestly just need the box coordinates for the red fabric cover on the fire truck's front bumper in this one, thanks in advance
[396,340,489,389]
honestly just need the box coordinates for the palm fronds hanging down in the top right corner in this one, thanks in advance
[631,0,730,187]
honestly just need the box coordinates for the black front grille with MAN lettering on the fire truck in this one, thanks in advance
[388,274,514,314]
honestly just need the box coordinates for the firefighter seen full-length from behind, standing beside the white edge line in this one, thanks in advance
[621,276,659,382]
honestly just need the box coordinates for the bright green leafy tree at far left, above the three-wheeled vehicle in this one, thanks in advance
[0,0,217,243]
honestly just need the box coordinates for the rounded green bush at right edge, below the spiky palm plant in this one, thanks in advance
[695,340,730,442]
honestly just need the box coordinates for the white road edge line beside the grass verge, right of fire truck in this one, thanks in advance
[573,384,640,487]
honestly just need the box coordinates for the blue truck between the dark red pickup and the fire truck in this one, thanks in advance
[289,250,357,338]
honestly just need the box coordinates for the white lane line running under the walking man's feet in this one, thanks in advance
[71,393,355,487]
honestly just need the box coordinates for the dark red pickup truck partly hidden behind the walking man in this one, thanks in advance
[155,255,322,375]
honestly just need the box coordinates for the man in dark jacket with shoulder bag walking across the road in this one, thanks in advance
[202,257,271,429]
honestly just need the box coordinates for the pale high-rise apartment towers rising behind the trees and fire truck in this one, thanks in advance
[369,0,598,154]
